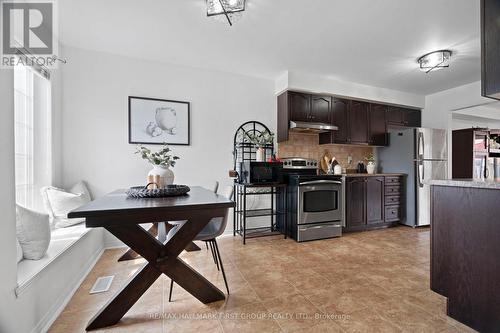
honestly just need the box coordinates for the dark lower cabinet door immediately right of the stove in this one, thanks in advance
[346,177,366,228]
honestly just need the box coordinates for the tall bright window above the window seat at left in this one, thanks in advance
[14,66,52,210]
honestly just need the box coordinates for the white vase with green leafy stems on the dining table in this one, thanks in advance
[135,143,179,188]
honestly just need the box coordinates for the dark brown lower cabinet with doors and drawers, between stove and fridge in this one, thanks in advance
[344,176,404,232]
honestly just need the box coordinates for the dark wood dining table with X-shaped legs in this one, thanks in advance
[68,186,235,331]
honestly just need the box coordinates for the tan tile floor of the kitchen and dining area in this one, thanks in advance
[50,227,473,333]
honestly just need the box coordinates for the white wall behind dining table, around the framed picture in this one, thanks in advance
[62,47,276,239]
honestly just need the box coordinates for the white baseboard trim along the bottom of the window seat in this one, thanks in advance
[36,244,106,333]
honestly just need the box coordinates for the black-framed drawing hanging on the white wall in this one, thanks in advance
[128,96,191,146]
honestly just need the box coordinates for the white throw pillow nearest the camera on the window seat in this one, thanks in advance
[16,205,50,260]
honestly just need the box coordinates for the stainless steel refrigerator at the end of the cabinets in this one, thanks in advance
[377,128,448,227]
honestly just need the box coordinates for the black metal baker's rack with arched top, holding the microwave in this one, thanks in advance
[233,121,286,244]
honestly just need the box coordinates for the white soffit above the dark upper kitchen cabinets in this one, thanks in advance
[275,71,425,108]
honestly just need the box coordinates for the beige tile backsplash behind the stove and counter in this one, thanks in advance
[278,132,374,169]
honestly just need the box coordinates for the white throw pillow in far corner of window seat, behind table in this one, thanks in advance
[42,182,91,228]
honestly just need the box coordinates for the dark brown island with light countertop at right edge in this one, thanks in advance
[428,179,500,332]
